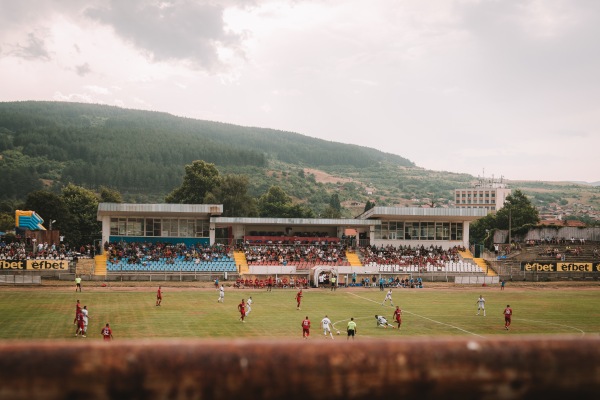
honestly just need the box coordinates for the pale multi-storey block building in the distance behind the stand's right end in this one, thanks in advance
[454,177,511,213]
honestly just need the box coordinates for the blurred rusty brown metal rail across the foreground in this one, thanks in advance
[0,338,600,400]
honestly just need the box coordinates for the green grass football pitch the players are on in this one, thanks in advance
[0,287,600,341]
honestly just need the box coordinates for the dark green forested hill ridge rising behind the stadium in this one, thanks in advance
[0,101,414,199]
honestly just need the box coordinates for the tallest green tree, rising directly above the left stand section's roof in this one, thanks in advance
[165,160,221,204]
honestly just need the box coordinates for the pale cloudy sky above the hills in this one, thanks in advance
[0,0,600,182]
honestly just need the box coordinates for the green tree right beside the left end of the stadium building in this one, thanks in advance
[60,183,101,247]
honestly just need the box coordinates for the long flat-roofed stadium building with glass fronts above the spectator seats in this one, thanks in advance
[97,203,487,249]
